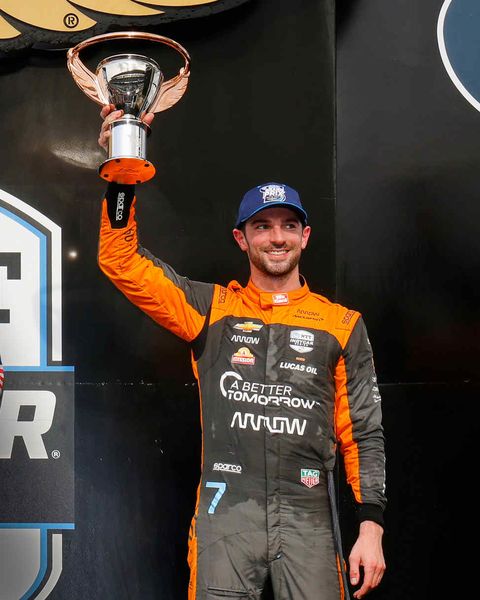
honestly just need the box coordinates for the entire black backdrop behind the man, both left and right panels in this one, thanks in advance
[0,0,480,600]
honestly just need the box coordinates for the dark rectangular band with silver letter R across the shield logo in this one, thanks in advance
[0,371,74,523]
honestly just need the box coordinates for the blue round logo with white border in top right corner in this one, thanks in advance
[437,0,480,111]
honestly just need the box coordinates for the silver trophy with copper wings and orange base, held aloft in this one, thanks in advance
[67,31,190,184]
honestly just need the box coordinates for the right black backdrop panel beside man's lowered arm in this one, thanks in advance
[335,0,480,600]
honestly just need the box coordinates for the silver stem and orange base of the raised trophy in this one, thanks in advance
[98,115,155,184]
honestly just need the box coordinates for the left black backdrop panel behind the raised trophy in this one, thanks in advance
[0,0,335,600]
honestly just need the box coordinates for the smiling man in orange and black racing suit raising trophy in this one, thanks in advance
[99,107,386,600]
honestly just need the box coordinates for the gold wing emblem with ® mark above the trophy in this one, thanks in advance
[0,0,253,52]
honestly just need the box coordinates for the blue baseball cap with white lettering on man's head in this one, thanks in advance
[235,181,308,228]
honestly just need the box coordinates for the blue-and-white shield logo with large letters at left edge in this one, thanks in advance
[0,190,74,600]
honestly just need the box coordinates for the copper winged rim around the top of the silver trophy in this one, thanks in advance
[67,31,190,112]
